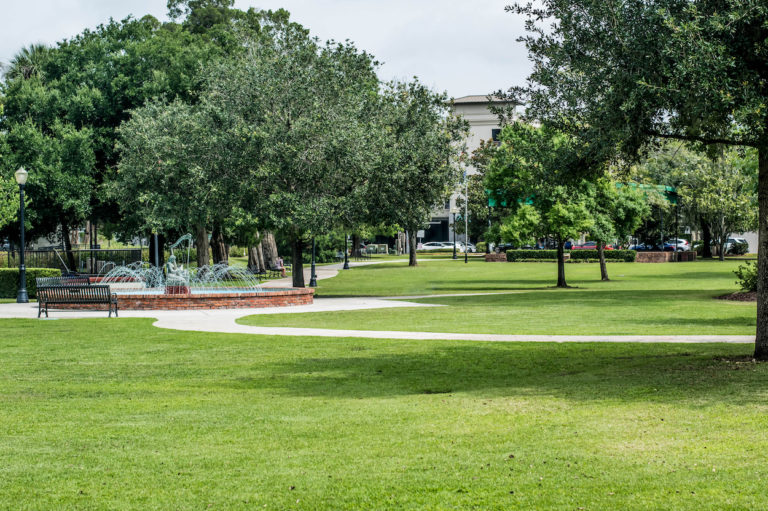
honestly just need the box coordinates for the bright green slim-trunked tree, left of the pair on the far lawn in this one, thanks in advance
[486,122,593,287]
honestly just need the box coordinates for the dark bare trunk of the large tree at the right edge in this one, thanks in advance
[755,144,768,360]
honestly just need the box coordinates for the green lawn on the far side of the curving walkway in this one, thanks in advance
[240,261,756,335]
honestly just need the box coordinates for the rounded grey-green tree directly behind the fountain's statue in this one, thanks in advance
[110,100,249,266]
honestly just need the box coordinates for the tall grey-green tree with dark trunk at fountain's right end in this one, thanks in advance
[206,23,379,287]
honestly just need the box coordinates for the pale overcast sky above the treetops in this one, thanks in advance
[0,0,530,97]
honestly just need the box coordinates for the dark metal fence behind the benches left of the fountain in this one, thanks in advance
[0,248,141,275]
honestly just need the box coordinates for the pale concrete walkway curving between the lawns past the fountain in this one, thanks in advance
[0,300,755,343]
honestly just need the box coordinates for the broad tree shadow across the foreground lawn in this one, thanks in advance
[252,341,768,406]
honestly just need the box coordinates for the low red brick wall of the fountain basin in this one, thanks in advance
[55,288,315,310]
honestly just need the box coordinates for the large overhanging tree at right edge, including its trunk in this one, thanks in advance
[508,0,768,359]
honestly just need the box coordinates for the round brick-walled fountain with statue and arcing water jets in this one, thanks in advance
[85,234,314,310]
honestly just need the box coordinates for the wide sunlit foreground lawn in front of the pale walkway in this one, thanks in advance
[0,319,768,510]
